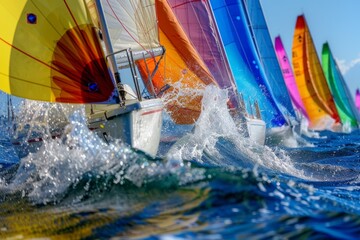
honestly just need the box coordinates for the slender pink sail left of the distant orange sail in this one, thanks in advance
[275,36,309,119]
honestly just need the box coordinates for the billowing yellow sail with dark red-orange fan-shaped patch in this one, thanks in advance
[0,0,114,103]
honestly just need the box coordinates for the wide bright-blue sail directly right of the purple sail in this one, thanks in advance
[209,0,287,128]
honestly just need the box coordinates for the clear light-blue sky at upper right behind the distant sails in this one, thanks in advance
[260,0,360,97]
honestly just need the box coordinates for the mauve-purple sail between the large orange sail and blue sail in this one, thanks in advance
[168,0,238,108]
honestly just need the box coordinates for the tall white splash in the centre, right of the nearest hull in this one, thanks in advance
[166,85,350,180]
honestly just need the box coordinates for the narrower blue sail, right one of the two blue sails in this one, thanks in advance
[242,0,296,119]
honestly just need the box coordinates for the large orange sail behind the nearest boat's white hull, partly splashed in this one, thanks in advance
[137,0,217,124]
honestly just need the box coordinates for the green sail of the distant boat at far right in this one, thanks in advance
[322,43,360,127]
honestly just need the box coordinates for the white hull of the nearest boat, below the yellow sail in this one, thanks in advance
[88,99,163,156]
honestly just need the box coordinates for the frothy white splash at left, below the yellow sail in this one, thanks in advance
[0,109,203,204]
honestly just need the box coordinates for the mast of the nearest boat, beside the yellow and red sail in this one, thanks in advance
[95,0,125,102]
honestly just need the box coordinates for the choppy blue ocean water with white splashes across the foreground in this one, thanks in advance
[0,86,360,239]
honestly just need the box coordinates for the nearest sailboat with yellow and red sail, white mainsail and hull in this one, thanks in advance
[0,0,163,155]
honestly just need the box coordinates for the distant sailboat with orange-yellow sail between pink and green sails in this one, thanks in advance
[292,15,341,131]
